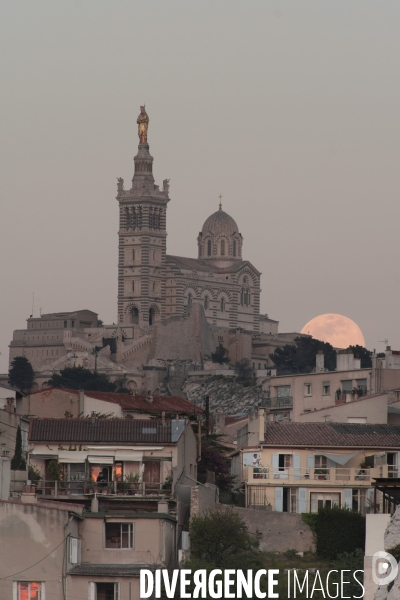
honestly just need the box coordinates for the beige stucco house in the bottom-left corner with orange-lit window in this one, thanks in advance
[0,494,178,600]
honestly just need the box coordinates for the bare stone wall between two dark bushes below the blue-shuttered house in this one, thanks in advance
[233,506,315,552]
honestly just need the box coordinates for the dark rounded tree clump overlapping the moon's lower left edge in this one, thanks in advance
[270,336,336,375]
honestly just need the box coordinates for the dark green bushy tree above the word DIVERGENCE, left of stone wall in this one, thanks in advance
[185,509,262,570]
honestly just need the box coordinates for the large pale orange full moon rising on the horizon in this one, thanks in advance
[301,313,365,348]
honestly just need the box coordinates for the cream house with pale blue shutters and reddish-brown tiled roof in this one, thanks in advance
[231,409,400,513]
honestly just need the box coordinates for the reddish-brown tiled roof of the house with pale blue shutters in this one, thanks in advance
[263,423,400,448]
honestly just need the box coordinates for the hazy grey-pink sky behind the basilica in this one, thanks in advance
[0,0,400,372]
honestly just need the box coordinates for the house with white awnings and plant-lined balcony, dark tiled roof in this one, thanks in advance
[28,416,197,504]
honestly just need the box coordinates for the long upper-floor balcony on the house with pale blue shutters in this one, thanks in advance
[243,465,386,487]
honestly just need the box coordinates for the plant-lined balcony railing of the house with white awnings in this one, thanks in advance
[35,479,172,497]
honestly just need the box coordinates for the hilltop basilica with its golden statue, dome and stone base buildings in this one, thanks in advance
[10,106,291,390]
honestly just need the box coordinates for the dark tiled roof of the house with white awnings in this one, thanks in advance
[28,418,178,444]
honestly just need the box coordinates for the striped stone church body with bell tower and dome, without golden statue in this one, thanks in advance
[117,110,261,337]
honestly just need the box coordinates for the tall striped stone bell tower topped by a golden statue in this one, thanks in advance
[116,106,169,337]
